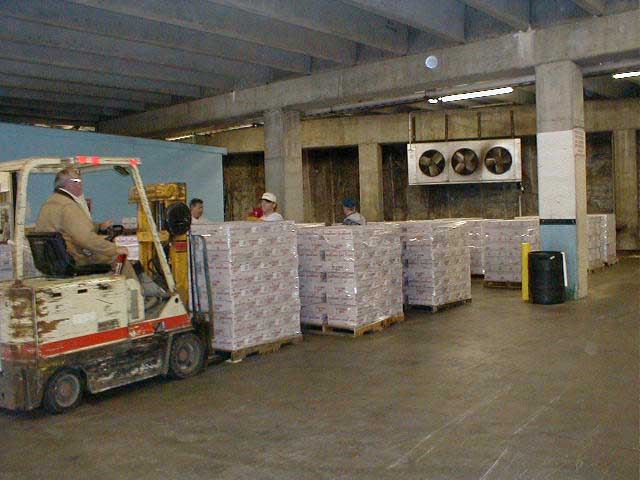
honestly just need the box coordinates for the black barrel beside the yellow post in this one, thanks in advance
[529,252,565,305]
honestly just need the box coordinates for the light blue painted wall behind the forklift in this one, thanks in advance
[0,123,226,224]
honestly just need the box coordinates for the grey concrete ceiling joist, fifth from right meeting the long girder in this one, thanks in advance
[73,0,356,65]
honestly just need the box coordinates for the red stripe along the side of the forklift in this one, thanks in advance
[38,315,191,357]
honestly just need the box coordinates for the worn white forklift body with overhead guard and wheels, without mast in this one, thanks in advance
[0,157,211,412]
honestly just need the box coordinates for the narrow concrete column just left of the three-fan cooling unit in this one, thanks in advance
[358,143,384,222]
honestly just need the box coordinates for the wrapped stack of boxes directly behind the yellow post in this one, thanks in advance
[482,218,540,283]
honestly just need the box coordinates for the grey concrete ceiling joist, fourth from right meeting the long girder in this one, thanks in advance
[210,0,408,55]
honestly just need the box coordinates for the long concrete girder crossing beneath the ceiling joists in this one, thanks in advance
[101,10,640,136]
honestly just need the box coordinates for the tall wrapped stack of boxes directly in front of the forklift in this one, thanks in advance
[191,222,300,351]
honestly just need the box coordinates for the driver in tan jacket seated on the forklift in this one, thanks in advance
[36,168,128,266]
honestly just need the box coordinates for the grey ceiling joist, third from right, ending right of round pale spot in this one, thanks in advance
[345,0,465,43]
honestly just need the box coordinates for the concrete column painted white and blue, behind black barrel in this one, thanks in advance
[536,61,589,298]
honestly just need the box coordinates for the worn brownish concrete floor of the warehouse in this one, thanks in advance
[0,258,640,480]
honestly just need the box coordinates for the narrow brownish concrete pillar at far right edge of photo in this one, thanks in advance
[613,130,640,250]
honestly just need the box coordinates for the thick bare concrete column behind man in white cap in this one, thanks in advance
[264,110,304,222]
